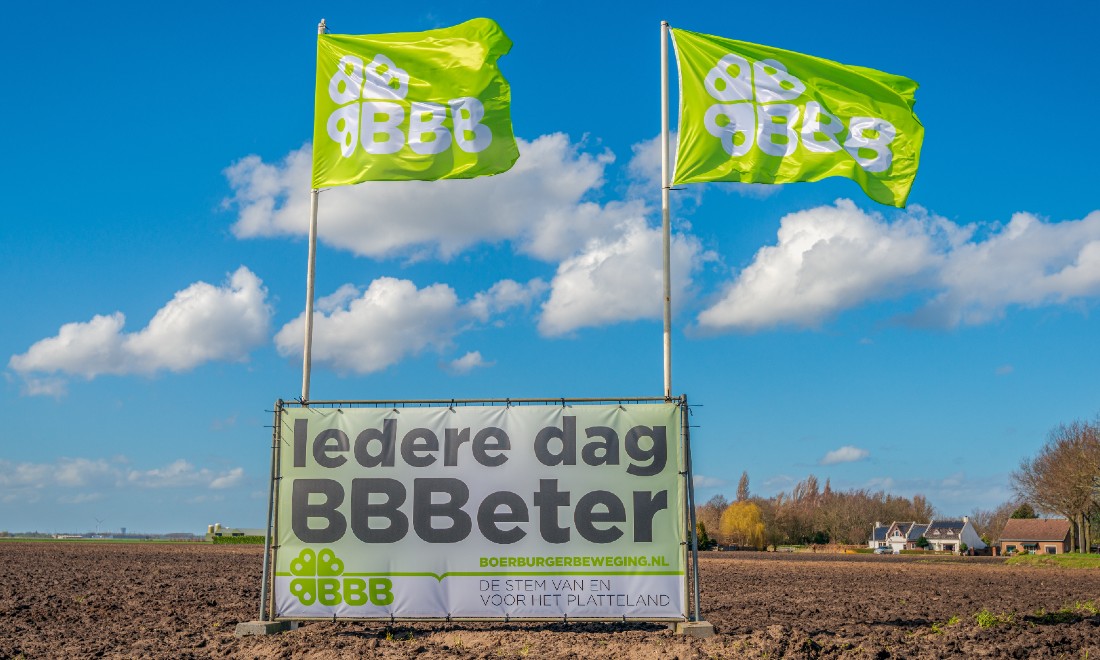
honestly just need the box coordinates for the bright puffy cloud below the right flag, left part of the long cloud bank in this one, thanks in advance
[699,199,939,330]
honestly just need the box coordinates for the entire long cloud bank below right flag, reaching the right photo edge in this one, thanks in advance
[697,199,1100,331]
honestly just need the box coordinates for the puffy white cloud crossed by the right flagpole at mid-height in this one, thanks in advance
[539,218,713,337]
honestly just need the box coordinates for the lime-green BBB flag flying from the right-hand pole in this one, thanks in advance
[672,30,924,207]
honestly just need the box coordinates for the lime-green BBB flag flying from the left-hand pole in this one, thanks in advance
[314,19,519,188]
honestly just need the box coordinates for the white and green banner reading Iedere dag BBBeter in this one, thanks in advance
[273,402,686,620]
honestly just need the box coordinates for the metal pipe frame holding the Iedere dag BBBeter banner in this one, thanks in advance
[260,395,700,624]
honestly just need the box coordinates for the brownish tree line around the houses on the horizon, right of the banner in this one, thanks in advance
[695,419,1100,551]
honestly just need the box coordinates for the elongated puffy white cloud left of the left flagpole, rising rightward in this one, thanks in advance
[8,266,271,389]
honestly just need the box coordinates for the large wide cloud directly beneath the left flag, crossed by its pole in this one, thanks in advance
[226,133,644,261]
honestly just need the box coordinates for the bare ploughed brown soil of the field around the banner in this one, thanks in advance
[0,542,1100,660]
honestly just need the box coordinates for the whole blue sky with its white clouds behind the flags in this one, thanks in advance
[0,2,1100,532]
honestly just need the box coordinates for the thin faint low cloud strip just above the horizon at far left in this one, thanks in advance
[0,457,244,504]
